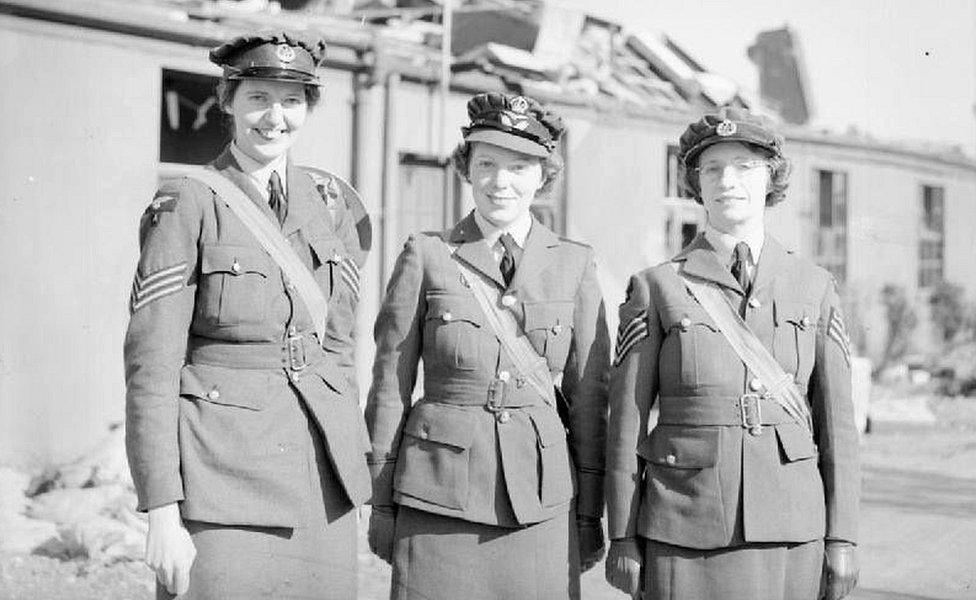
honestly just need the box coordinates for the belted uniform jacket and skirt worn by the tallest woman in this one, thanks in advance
[125,146,369,598]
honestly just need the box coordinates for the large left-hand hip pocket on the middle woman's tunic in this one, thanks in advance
[394,403,475,510]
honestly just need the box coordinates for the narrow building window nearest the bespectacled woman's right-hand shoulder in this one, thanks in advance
[814,170,847,283]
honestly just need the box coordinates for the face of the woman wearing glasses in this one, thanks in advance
[698,142,769,233]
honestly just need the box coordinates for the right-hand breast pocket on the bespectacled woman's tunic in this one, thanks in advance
[773,300,817,382]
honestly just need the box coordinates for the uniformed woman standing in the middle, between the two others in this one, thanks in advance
[366,93,609,600]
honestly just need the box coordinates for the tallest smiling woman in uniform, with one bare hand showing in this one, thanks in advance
[125,32,369,600]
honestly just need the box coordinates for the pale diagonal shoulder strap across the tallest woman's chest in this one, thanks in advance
[189,169,329,343]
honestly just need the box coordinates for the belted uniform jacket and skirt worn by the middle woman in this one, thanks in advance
[366,213,609,598]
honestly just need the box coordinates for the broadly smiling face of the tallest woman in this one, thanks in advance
[224,79,308,164]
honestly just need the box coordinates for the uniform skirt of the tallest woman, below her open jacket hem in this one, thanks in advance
[156,406,357,600]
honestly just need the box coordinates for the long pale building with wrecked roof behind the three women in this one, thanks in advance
[0,0,976,464]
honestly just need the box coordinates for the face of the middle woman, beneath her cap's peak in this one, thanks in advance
[468,142,543,228]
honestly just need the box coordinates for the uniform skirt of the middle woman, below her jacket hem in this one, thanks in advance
[390,506,580,600]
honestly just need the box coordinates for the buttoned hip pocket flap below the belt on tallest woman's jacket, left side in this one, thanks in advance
[180,364,270,410]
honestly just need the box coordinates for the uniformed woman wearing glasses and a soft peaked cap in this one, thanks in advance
[606,109,859,600]
